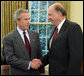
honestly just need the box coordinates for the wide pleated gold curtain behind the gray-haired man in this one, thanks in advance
[1,1,26,47]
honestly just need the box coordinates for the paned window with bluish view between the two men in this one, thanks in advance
[29,1,56,55]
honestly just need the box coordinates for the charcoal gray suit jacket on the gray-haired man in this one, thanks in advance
[3,29,44,75]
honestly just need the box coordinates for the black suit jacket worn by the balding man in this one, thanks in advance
[41,20,83,75]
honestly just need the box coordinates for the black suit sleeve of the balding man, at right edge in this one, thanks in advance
[67,24,83,74]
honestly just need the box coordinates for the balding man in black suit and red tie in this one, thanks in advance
[32,3,83,75]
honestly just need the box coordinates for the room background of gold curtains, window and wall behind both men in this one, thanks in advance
[1,1,83,70]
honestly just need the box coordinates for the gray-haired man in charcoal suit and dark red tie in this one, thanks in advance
[3,9,44,75]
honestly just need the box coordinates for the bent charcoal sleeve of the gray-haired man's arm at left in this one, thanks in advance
[3,36,29,71]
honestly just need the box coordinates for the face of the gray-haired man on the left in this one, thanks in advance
[17,13,30,31]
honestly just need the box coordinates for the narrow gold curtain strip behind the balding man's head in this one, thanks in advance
[56,1,70,20]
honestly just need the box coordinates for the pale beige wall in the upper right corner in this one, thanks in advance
[70,1,83,31]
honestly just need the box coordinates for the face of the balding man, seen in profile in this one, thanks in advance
[48,7,59,26]
